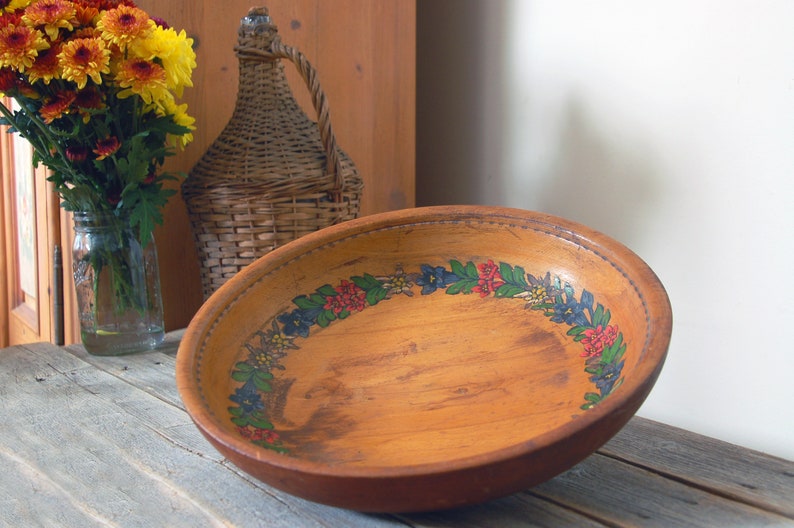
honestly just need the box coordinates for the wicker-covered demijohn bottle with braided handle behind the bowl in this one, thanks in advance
[182,8,363,298]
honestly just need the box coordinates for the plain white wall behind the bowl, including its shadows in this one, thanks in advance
[417,0,794,459]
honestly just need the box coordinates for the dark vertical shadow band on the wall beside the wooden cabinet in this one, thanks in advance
[416,0,507,206]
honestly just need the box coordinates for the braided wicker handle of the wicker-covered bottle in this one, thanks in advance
[237,35,345,203]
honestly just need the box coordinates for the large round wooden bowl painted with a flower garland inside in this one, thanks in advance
[177,206,672,512]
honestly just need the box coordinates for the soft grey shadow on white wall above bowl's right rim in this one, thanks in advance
[535,99,663,248]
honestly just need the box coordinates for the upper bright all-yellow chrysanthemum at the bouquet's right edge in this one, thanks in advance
[130,26,196,97]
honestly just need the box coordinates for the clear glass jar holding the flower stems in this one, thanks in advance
[72,212,165,356]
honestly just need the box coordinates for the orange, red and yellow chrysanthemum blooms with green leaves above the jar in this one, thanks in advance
[0,0,196,245]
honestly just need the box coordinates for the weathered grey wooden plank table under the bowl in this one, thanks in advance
[0,335,794,528]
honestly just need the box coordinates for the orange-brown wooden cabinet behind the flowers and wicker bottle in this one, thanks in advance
[0,0,416,344]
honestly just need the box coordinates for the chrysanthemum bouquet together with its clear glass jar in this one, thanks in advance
[0,0,196,353]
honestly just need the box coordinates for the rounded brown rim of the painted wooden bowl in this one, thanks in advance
[176,205,672,479]
